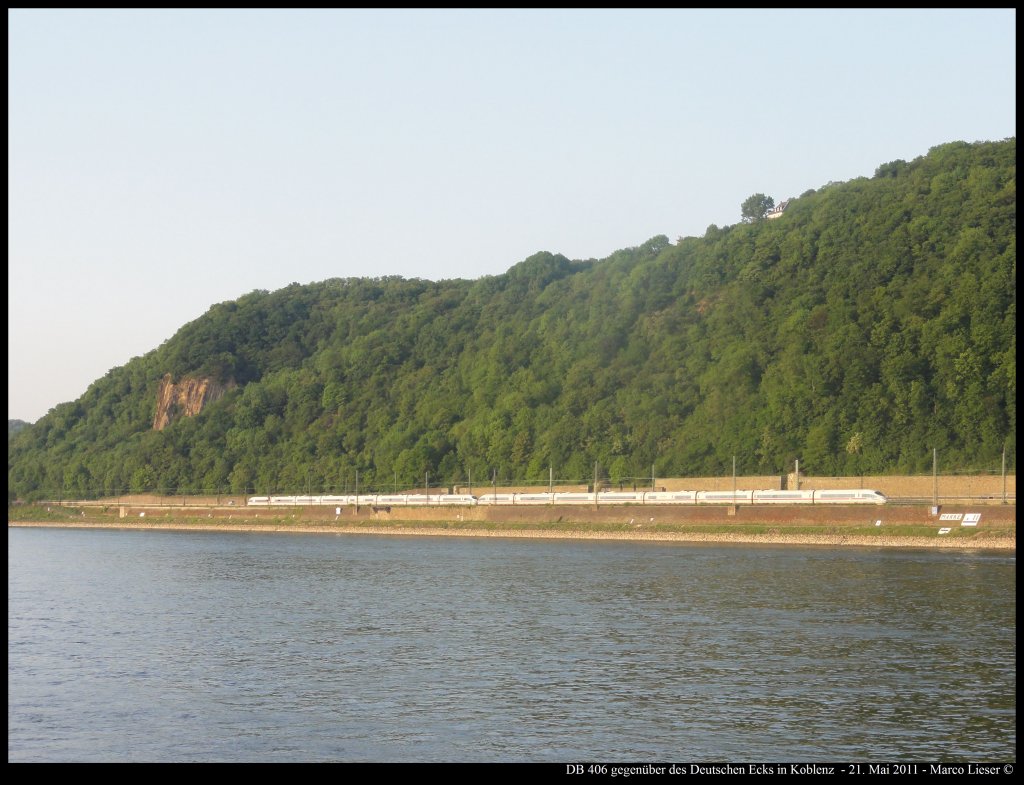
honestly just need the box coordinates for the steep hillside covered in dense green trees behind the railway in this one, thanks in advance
[8,139,1017,498]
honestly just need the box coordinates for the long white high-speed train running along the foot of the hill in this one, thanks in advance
[246,488,887,507]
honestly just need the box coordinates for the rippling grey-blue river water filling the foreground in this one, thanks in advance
[7,528,1017,762]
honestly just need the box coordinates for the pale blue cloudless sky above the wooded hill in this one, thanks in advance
[7,8,1017,422]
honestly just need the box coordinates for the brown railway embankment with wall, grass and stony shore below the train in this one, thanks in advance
[8,504,1017,550]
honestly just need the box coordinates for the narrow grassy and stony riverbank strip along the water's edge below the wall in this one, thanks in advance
[7,515,1017,551]
